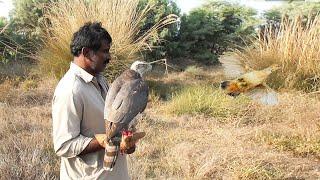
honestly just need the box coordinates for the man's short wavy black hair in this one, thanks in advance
[70,22,112,57]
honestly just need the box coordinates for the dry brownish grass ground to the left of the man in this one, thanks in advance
[0,77,59,179]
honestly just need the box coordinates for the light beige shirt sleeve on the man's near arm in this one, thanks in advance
[52,88,93,158]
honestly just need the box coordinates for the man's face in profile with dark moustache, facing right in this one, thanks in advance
[89,41,111,74]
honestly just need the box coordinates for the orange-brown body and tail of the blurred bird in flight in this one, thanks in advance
[220,64,280,96]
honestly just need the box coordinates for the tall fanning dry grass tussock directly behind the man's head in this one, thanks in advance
[36,0,176,80]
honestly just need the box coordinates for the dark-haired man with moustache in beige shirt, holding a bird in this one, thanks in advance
[52,22,129,180]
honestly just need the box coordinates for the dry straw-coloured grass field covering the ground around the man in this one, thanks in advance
[0,64,320,179]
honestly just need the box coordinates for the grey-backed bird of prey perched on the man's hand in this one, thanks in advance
[104,61,152,170]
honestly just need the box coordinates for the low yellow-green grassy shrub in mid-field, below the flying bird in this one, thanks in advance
[164,85,249,120]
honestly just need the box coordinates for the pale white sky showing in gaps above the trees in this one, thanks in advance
[0,0,283,17]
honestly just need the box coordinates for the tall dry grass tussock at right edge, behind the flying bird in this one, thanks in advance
[236,16,320,91]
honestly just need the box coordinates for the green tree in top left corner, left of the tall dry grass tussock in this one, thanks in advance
[1,0,53,62]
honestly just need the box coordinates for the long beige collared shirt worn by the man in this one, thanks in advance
[52,63,129,180]
